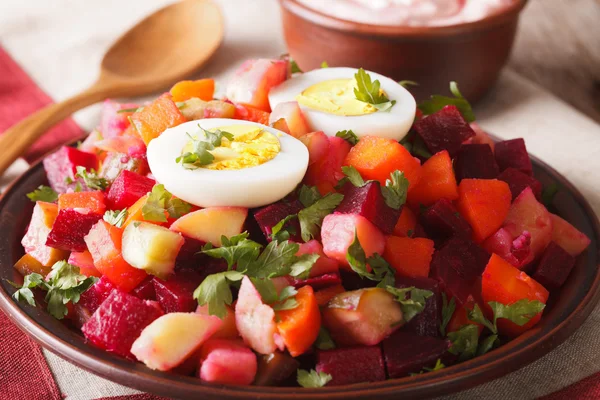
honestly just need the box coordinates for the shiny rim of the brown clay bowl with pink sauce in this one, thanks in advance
[279,0,529,38]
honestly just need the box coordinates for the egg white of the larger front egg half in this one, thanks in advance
[147,118,308,208]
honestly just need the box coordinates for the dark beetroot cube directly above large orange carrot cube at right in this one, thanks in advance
[454,144,500,182]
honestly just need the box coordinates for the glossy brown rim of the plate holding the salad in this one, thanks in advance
[0,148,600,400]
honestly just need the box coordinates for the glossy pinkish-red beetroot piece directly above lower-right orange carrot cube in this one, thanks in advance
[483,228,534,269]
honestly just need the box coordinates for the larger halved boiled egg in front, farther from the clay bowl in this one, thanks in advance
[147,118,308,208]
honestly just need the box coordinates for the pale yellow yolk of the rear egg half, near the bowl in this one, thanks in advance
[296,79,377,116]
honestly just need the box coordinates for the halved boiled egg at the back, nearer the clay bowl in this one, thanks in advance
[269,68,417,140]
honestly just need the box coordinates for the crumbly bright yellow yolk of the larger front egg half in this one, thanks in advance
[182,125,281,170]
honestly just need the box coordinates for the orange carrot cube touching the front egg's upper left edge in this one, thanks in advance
[131,94,186,145]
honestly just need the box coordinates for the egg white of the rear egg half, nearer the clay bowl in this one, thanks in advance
[269,68,417,140]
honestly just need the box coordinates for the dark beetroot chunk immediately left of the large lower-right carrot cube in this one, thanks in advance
[431,237,490,305]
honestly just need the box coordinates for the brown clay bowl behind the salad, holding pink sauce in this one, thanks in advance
[280,0,527,102]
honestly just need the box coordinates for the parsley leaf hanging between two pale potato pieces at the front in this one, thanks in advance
[194,271,244,319]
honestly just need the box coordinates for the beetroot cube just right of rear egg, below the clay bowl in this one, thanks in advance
[413,106,475,157]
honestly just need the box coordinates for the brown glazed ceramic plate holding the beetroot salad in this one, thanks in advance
[0,148,600,400]
